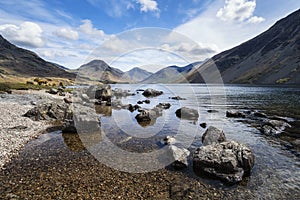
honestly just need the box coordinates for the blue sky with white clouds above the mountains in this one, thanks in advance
[0,0,300,72]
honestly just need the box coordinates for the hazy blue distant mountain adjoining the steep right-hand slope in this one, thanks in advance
[142,62,201,83]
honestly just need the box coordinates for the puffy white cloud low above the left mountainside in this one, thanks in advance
[0,22,44,47]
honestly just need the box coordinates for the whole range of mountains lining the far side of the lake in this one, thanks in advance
[0,9,300,85]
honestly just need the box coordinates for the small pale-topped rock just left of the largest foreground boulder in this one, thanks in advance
[169,145,190,170]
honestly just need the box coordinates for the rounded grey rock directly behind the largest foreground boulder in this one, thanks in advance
[202,126,226,146]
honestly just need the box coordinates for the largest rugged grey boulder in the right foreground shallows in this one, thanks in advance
[193,141,254,183]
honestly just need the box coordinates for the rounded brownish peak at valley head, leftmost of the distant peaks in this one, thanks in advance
[77,60,126,83]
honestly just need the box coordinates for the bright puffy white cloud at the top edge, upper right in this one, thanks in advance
[217,0,263,23]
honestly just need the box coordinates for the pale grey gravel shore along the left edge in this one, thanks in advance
[0,90,62,168]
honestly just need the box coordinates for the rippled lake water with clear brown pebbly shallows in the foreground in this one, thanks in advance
[0,84,300,199]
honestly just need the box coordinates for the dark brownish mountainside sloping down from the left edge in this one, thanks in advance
[0,35,75,79]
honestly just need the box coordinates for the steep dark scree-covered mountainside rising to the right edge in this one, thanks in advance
[186,10,300,85]
